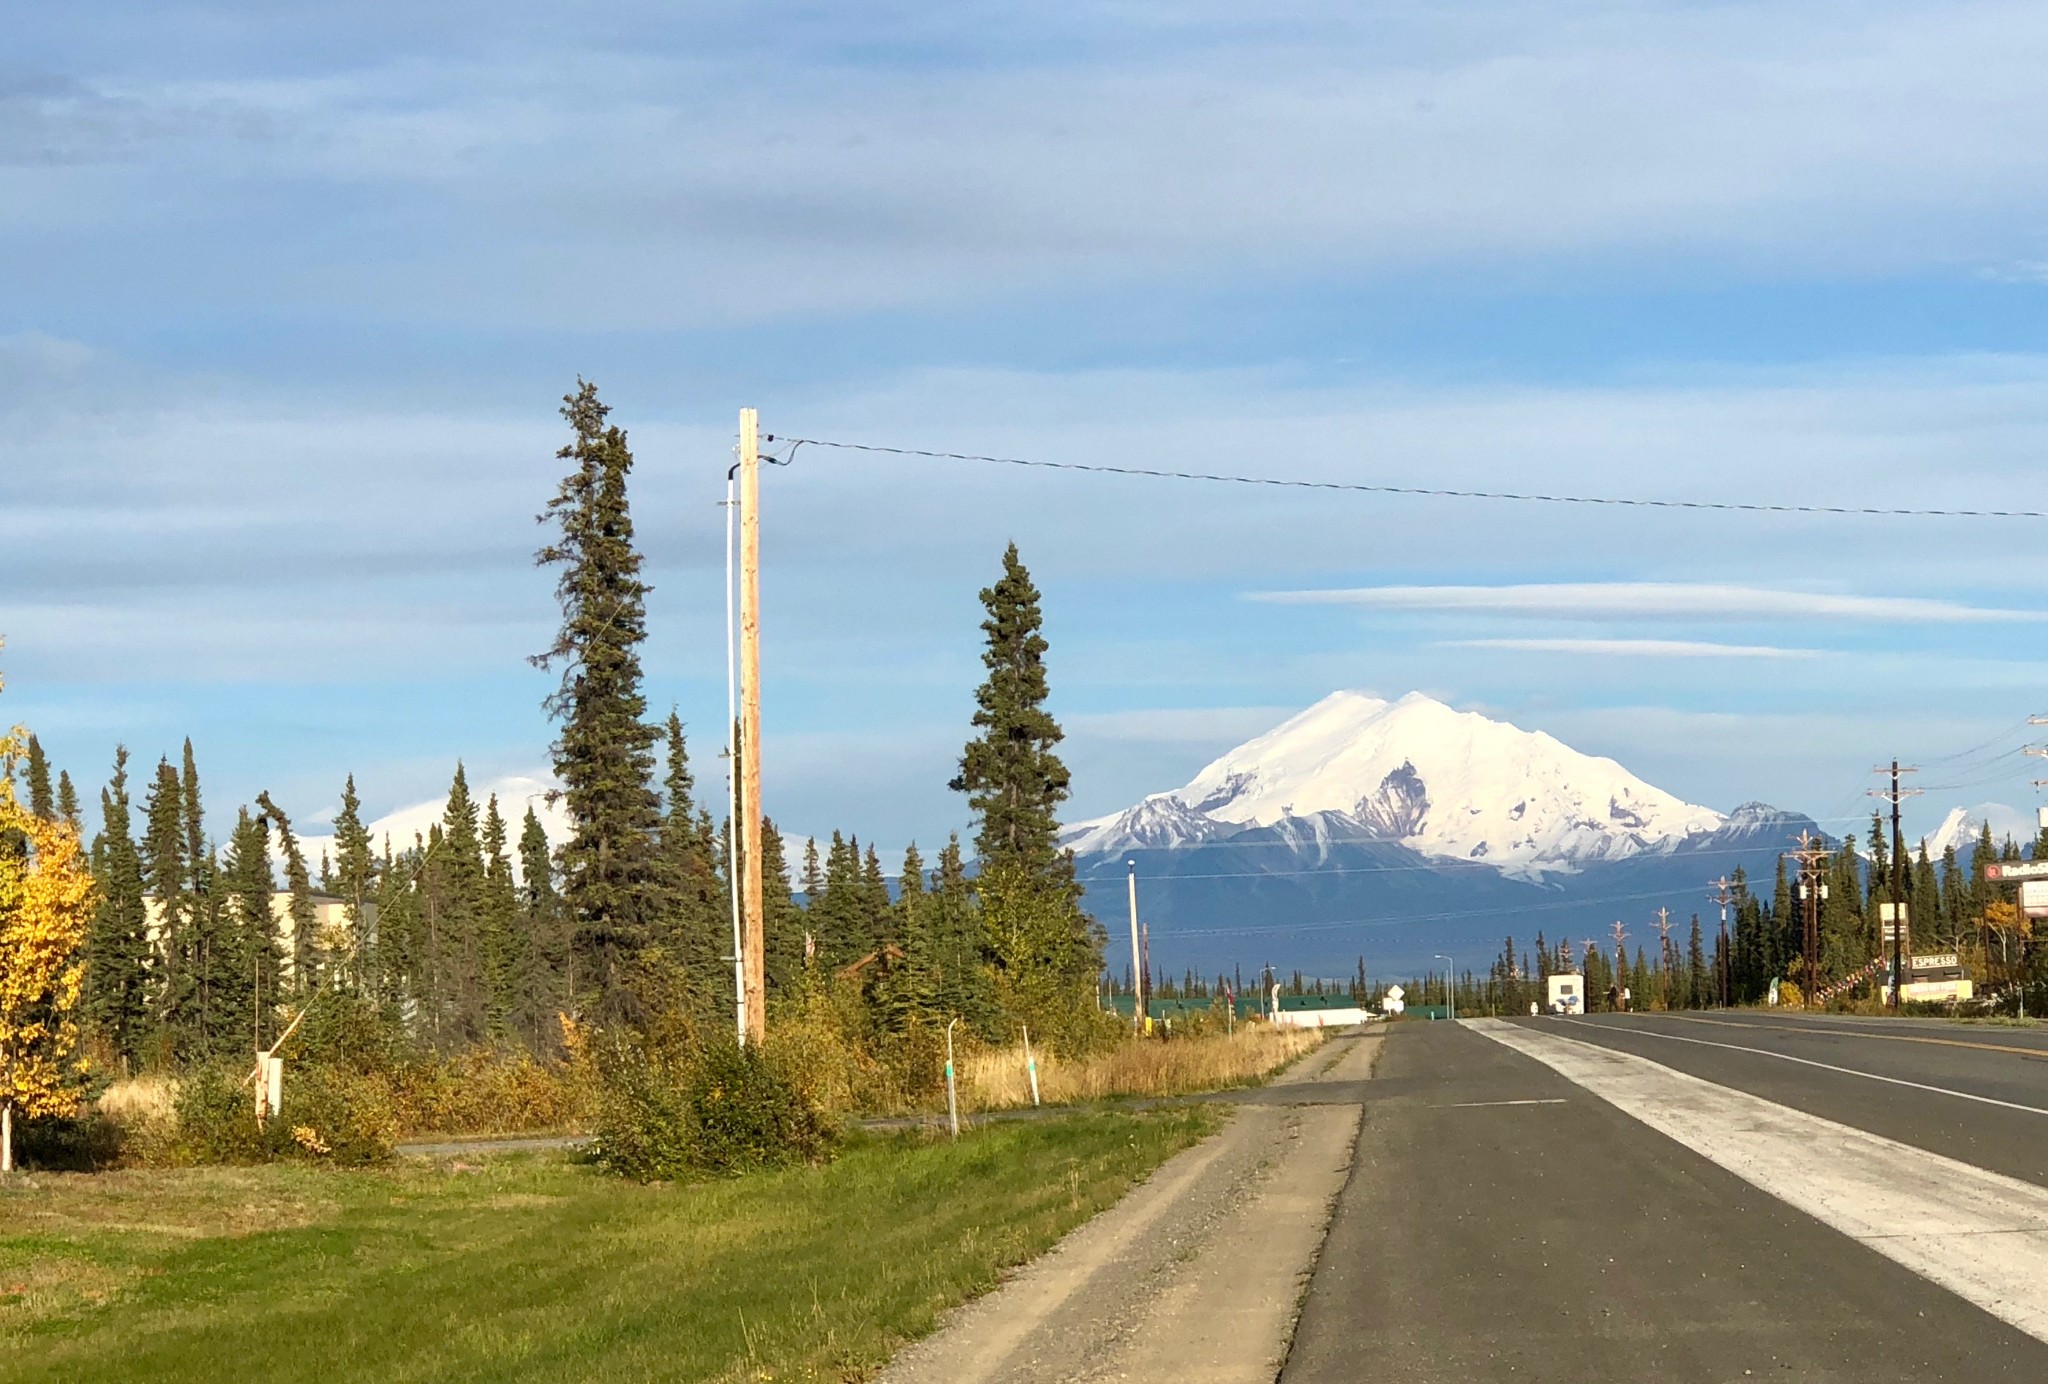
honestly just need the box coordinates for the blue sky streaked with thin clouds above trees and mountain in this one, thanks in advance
[0,0,2048,848]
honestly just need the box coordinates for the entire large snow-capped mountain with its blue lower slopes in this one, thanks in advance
[1061,692,1819,975]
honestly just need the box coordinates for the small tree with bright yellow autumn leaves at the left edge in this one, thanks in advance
[0,729,94,1173]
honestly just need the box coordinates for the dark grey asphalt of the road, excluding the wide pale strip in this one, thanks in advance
[1280,1015,2048,1384]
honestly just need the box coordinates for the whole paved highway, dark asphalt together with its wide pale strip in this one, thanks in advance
[1282,1013,2048,1384]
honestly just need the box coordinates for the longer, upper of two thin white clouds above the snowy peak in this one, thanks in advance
[1249,581,2048,622]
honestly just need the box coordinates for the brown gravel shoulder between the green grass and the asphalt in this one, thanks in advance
[881,1034,1380,1384]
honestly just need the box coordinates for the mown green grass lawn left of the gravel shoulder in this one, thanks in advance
[0,1110,1217,1384]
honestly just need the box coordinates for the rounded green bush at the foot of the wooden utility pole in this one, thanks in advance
[592,1034,836,1181]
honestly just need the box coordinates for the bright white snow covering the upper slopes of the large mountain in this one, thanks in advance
[1065,692,1726,878]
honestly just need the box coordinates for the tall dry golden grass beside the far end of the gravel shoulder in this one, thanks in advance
[961,1024,1325,1110]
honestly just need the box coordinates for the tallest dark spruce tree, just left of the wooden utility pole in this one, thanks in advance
[535,381,662,1020]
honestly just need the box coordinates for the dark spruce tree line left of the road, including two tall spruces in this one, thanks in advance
[20,383,1104,1071]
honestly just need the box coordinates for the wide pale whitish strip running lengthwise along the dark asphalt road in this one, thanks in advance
[1468,1020,2048,1341]
